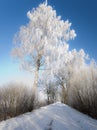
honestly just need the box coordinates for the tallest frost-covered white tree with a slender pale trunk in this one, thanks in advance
[12,0,76,95]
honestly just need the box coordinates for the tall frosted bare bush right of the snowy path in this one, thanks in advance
[68,67,97,119]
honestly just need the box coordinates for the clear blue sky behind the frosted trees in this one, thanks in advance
[0,0,97,83]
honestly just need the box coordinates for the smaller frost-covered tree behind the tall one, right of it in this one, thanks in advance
[53,46,88,103]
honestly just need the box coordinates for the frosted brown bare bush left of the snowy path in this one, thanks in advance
[0,83,35,120]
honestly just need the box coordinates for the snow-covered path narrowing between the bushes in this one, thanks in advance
[0,102,97,130]
